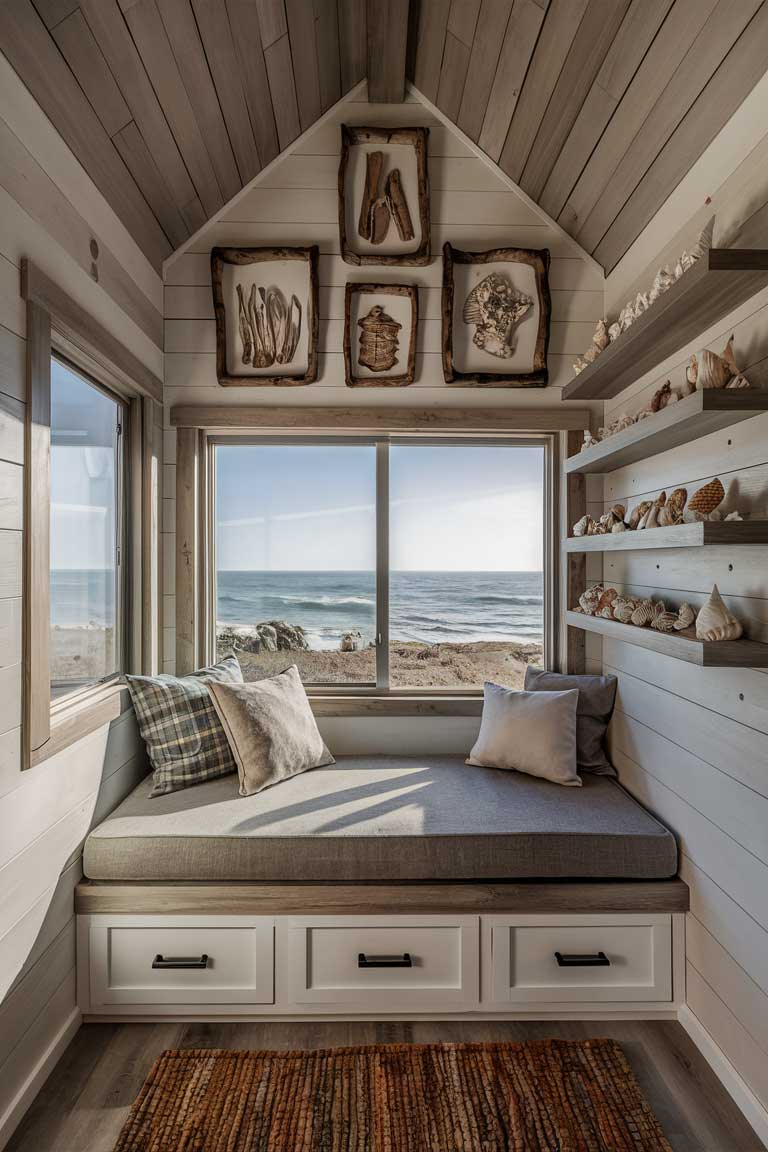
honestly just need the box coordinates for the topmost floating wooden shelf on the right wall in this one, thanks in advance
[562,248,768,400]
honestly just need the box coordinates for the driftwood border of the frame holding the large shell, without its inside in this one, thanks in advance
[442,243,552,388]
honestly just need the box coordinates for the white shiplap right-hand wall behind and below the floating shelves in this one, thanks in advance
[603,123,768,1137]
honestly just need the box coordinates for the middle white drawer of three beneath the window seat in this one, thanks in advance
[287,916,480,1011]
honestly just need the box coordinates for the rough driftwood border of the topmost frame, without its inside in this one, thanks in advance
[339,124,432,267]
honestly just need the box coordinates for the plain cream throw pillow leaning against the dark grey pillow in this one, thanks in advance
[465,683,581,788]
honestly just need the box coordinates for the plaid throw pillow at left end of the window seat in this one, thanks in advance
[126,655,243,796]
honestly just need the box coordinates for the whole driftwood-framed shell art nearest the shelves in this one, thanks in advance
[442,244,550,388]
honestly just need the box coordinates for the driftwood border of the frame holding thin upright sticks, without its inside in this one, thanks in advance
[211,244,320,388]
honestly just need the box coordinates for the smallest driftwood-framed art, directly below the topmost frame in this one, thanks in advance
[344,283,419,388]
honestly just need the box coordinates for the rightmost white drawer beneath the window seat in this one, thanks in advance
[487,914,672,1005]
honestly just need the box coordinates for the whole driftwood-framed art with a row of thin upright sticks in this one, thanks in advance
[211,244,319,388]
